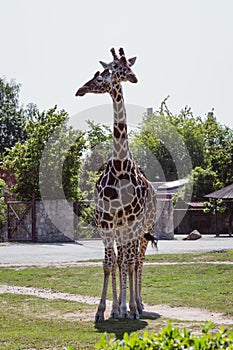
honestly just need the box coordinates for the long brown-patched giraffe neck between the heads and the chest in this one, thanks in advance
[111,81,131,159]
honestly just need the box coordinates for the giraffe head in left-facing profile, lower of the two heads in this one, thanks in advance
[75,69,111,96]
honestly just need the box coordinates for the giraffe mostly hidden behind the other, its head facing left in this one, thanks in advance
[76,51,156,313]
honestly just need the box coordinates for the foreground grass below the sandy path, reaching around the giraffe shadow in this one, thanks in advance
[0,294,164,350]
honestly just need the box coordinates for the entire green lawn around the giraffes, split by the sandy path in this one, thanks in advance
[0,251,233,350]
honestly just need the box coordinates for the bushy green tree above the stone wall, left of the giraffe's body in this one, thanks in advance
[4,107,85,200]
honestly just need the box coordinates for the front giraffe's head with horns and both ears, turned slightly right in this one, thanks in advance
[100,48,138,83]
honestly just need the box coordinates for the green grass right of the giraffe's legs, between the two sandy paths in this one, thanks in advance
[143,264,233,317]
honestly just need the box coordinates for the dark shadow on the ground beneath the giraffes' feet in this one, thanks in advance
[95,311,160,339]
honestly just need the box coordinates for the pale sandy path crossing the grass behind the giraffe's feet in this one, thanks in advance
[0,285,233,325]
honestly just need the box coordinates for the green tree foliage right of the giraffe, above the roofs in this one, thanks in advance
[131,99,233,200]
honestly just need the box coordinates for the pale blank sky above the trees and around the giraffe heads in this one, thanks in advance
[0,0,233,127]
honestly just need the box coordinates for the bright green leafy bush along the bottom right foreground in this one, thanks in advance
[95,323,233,350]
